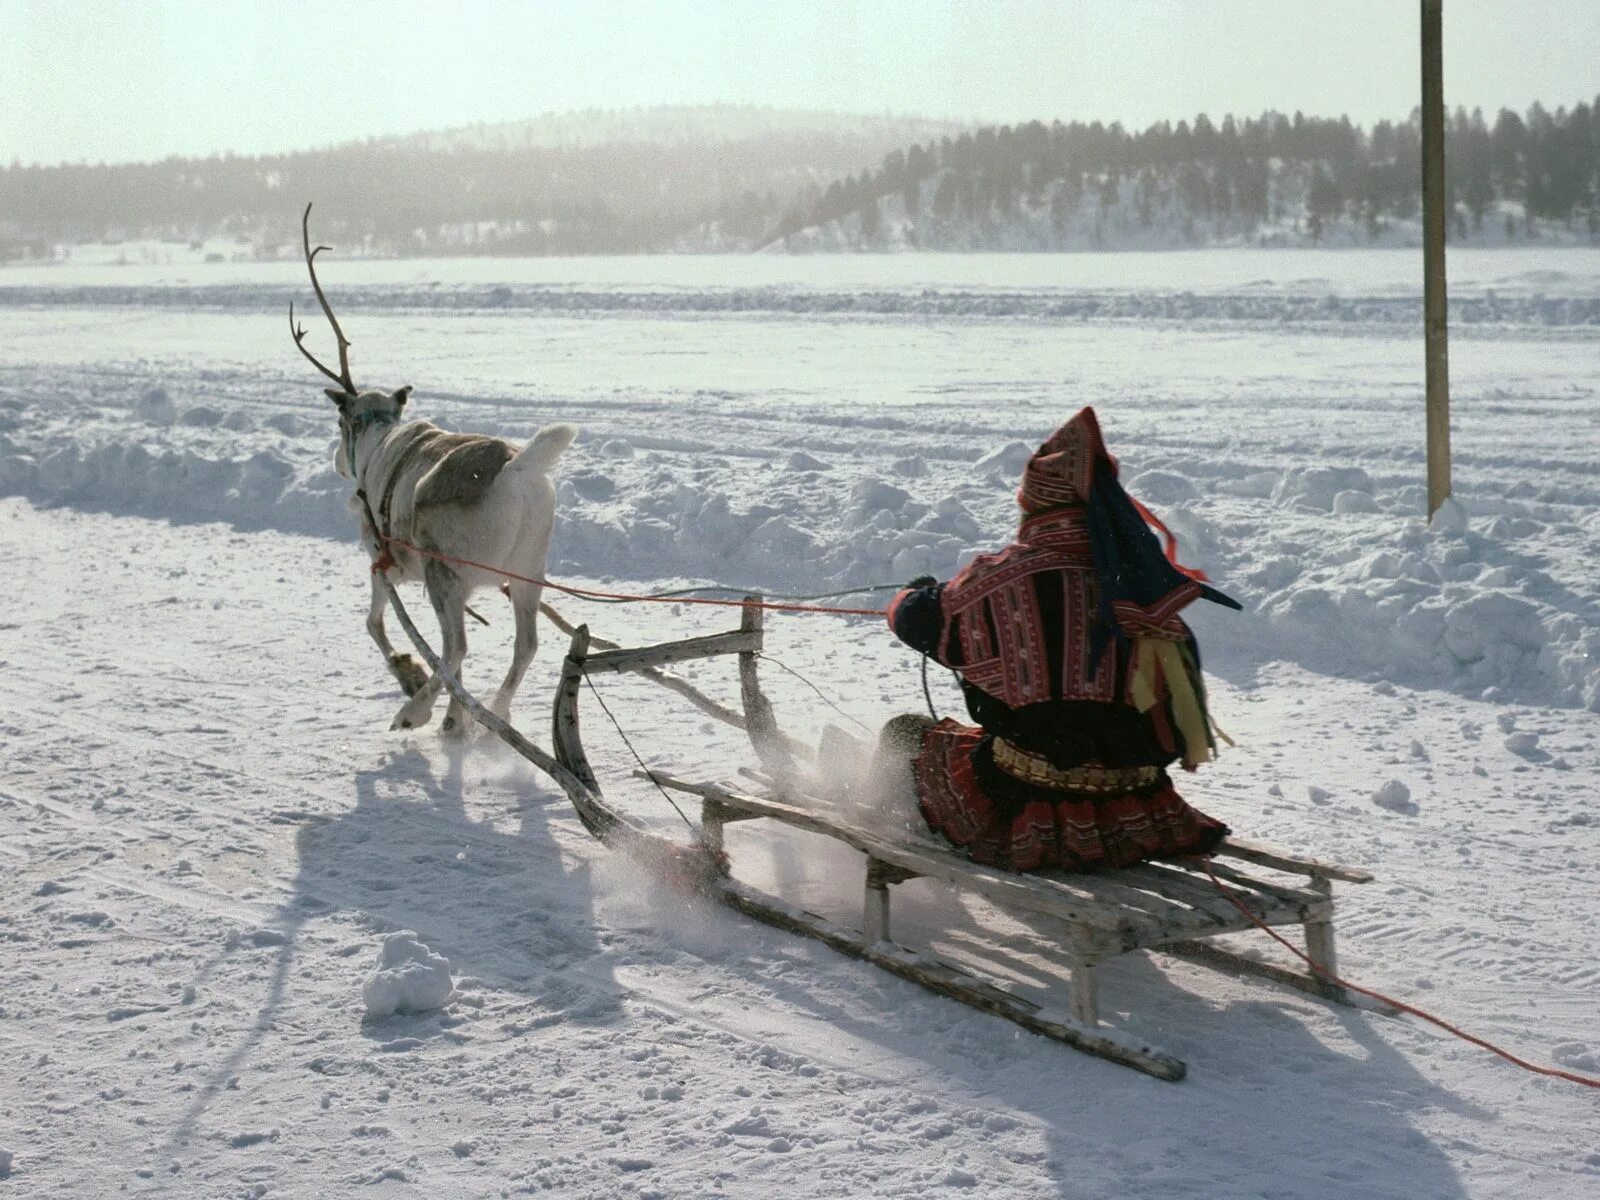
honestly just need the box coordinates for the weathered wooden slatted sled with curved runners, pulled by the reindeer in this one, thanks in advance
[544,597,1373,1080]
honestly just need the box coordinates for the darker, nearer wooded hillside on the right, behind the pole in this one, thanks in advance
[771,99,1600,250]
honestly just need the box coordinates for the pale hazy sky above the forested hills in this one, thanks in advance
[0,0,1600,163]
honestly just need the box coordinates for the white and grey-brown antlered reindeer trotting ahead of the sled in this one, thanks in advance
[290,205,578,736]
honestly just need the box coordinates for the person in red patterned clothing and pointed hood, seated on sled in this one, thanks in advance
[875,408,1238,870]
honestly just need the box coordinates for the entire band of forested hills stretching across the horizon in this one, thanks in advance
[0,99,1600,259]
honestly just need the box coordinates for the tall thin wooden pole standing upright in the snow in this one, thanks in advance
[1422,0,1450,520]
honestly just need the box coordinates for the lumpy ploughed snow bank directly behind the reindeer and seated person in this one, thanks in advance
[0,390,1600,710]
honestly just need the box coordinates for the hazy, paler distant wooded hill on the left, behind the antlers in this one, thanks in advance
[0,110,950,256]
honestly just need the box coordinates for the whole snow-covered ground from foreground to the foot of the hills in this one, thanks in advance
[0,250,1600,1200]
